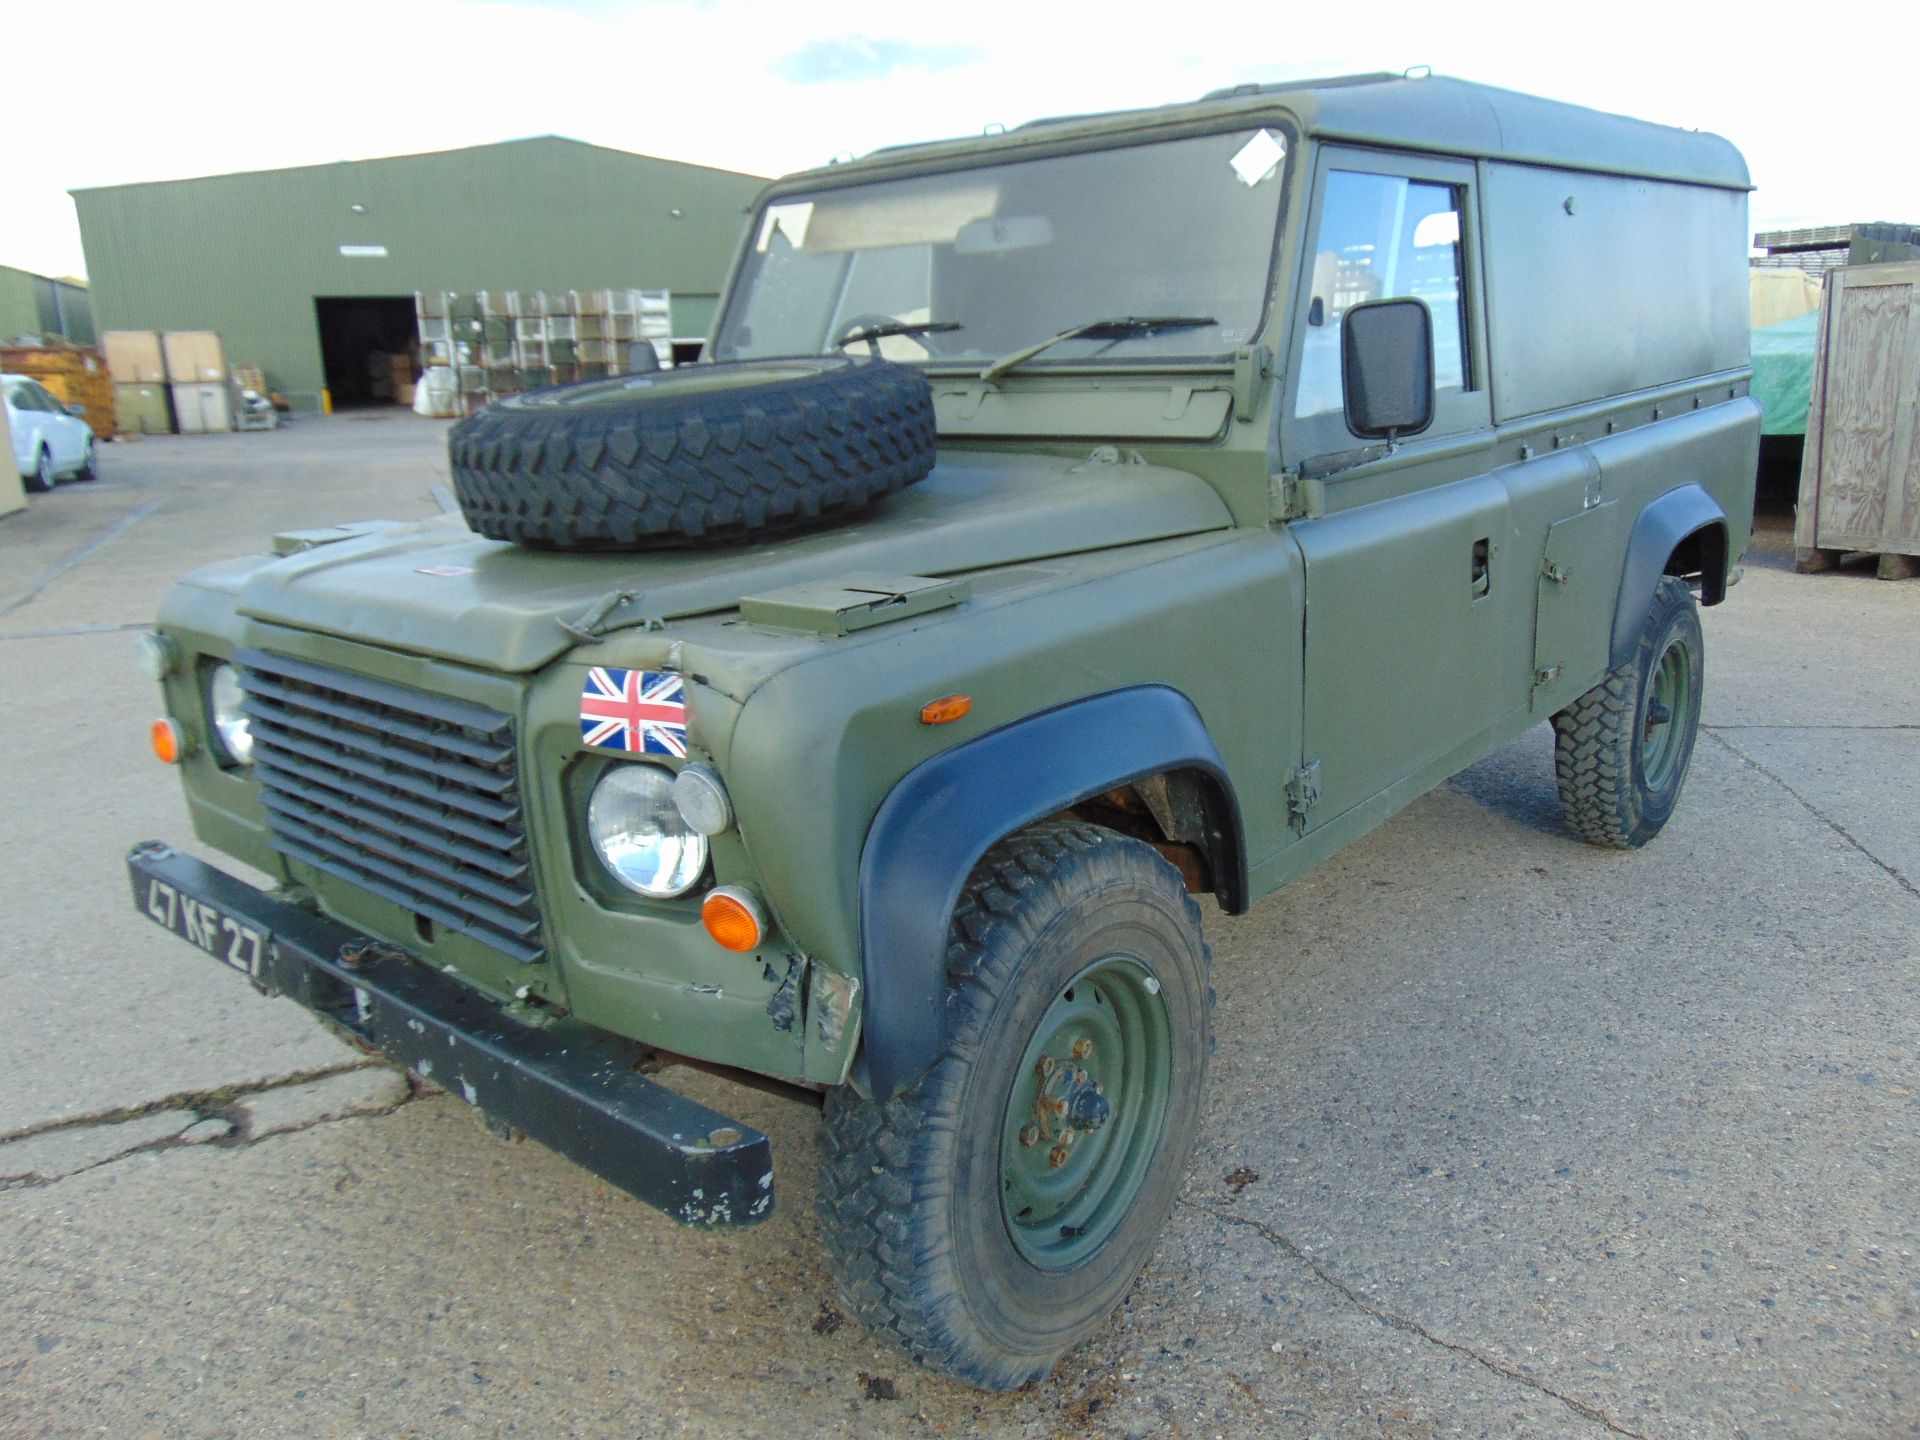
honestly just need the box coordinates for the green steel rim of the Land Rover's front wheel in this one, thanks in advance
[1000,956,1173,1271]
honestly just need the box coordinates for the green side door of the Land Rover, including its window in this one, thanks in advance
[1283,148,1505,831]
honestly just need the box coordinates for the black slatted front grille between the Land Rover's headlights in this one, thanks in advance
[234,651,545,964]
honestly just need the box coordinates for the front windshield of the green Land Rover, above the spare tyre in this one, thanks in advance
[714,127,1288,365]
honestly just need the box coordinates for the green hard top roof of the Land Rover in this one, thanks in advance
[816,75,1751,190]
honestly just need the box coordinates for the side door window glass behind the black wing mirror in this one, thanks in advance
[1294,171,1473,419]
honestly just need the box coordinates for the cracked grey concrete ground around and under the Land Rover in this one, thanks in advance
[0,417,1920,1440]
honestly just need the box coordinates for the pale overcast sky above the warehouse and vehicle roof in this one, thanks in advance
[0,0,1920,275]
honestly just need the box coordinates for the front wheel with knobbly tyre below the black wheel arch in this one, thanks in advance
[818,822,1213,1390]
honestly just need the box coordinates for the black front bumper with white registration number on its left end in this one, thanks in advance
[127,841,774,1227]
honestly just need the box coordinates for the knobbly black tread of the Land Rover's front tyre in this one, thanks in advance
[816,822,1213,1390]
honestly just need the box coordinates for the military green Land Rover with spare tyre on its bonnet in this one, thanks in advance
[131,75,1759,1388]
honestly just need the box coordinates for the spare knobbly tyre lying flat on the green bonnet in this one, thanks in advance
[447,355,935,551]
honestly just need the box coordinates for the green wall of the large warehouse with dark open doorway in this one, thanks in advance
[73,136,764,390]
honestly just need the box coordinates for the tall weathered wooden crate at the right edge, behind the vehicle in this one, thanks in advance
[1793,263,1920,578]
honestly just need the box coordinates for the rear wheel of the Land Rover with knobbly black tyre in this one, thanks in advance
[1553,576,1707,849]
